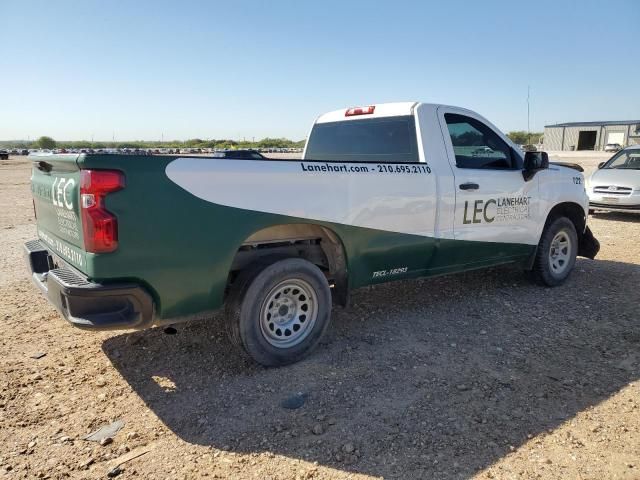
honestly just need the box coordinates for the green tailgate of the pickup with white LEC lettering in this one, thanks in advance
[29,155,86,272]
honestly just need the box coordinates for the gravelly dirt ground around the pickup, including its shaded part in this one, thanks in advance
[0,159,640,480]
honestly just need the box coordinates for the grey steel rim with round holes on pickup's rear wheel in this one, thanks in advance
[260,278,318,348]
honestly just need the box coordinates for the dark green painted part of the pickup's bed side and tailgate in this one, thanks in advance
[28,155,535,319]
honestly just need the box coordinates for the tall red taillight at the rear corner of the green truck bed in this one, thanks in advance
[80,170,124,253]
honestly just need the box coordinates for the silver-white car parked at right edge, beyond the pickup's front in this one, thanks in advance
[586,145,640,212]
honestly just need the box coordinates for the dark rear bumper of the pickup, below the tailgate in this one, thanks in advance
[24,240,154,330]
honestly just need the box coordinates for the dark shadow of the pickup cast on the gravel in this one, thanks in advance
[103,260,640,478]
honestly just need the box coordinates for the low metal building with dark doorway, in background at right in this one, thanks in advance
[543,120,640,151]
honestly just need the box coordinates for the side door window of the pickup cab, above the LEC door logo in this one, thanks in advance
[444,113,517,170]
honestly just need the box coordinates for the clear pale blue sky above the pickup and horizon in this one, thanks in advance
[0,0,640,140]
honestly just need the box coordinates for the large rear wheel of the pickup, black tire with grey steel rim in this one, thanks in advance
[225,258,331,367]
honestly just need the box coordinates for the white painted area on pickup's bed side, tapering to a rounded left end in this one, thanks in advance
[166,158,437,237]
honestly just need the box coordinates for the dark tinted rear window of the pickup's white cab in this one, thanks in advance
[305,115,419,163]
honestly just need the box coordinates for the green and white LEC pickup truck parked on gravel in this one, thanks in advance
[25,103,599,366]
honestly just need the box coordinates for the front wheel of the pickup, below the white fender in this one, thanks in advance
[529,217,578,287]
